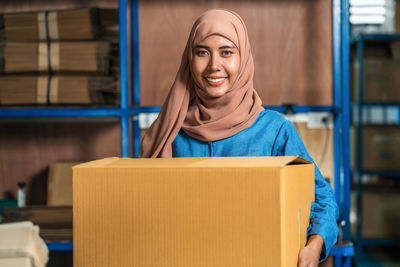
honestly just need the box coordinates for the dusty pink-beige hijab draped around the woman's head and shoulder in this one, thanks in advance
[140,9,263,158]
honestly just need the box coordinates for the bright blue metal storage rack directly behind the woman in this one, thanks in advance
[0,0,354,266]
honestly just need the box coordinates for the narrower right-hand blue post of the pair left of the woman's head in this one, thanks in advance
[131,0,140,158]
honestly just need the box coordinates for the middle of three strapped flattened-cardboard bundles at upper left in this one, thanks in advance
[0,41,111,74]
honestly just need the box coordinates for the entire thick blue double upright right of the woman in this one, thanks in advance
[332,0,353,266]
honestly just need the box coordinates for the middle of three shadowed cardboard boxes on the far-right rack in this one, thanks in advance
[363,125,400,171]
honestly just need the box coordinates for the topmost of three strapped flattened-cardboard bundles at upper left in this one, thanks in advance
[0,8,118,42]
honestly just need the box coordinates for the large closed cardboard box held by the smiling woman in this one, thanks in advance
[73,157,314,267]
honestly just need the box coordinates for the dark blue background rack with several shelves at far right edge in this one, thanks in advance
[353,34,400,260]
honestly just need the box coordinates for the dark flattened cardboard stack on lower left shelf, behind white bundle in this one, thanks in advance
[3,206,72,241]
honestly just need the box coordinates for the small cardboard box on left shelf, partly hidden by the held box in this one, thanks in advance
[47,162,80,206]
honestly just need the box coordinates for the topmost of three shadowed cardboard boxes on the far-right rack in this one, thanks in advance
[353,58,400,103]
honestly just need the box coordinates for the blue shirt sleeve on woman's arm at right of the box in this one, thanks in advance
[272,120,339,261]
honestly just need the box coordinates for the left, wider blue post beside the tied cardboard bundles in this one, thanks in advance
[118,0,130,158]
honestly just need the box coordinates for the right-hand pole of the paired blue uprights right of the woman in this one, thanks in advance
[341,0,351,243]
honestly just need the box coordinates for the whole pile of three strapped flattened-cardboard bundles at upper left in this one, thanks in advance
[0,8,119,105]
